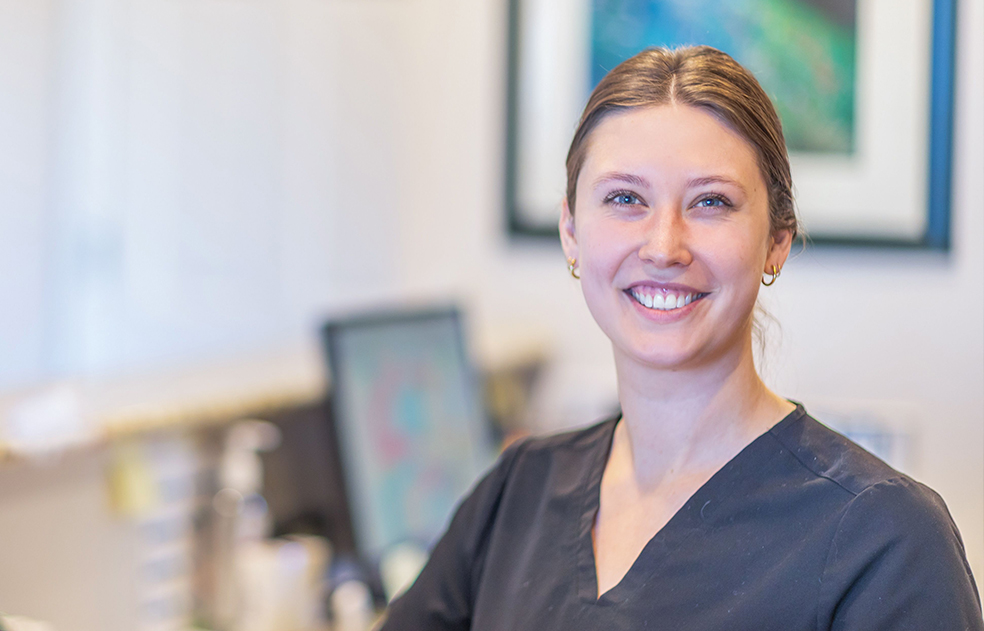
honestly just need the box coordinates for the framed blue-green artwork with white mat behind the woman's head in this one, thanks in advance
[506,0,956,250]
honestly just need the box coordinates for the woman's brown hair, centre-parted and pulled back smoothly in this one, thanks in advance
[567,46,798,238]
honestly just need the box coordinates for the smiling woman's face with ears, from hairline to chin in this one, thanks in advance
[560,105,791,369]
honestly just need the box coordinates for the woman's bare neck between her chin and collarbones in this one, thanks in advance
[613,339,793,486]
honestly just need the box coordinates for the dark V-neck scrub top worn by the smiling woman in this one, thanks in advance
[383,406,984,631]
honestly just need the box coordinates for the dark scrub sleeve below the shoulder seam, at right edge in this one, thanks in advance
[817,478,984,631]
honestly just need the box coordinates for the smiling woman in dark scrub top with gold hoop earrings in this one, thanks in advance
[384,47,984,631]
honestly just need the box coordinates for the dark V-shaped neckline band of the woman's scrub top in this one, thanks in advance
[573,403,806,606]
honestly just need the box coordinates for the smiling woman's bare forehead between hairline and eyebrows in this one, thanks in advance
[579,104,764,189]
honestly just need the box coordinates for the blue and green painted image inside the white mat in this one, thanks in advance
[591,0,857,154]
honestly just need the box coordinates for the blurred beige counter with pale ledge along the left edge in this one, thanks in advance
[0,349,326,631]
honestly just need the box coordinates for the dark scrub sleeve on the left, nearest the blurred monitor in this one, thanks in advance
[379,443,522,631]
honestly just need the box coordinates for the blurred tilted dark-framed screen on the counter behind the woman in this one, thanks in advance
[323,308,493,560]
